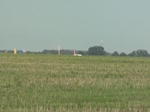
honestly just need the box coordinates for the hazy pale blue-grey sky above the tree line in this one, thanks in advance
[0,0,150,53]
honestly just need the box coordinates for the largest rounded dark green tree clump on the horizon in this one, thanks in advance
[88,46,105,55]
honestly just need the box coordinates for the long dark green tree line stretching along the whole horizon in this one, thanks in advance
[0,46,150,57]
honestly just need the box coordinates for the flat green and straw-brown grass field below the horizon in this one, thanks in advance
[0,54,150,112]
